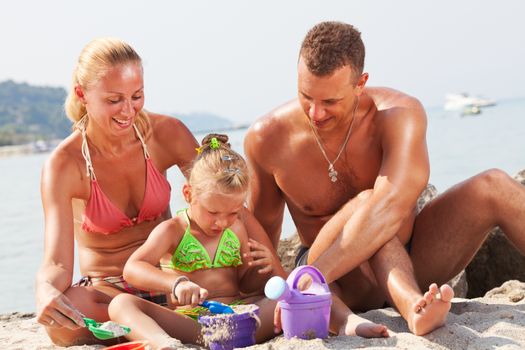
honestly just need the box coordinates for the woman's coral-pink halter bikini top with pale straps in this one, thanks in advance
[81,125,171,234]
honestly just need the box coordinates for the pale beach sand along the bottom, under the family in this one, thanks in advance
[4,281,525,350]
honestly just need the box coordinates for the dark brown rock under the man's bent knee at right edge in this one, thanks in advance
[465,170,525,298]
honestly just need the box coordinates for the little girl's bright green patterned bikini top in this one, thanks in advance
[161,209,242,272]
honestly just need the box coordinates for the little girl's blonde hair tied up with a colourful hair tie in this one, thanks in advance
[189,134,249,193]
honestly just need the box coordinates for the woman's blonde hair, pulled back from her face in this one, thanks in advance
[64,38,149,135]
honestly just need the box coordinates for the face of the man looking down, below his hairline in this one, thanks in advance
[298,57,366,131]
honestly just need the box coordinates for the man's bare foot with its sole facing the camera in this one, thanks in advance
[407,283,454,335]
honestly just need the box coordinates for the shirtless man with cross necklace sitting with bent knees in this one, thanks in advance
[245,22,525,335]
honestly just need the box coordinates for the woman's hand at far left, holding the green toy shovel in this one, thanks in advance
[37,285,85,330]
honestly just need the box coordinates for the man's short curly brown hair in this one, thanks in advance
[300,22,365,78]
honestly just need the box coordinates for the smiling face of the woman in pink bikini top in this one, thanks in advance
[81,62,144,136]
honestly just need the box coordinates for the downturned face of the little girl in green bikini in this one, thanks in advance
[183,185,246,236]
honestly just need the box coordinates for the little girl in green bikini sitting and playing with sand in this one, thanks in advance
[109,135,285,349]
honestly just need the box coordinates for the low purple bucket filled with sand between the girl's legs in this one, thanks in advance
[199,305,259,350]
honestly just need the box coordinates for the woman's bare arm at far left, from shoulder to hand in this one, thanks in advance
[35,151,84,329]
